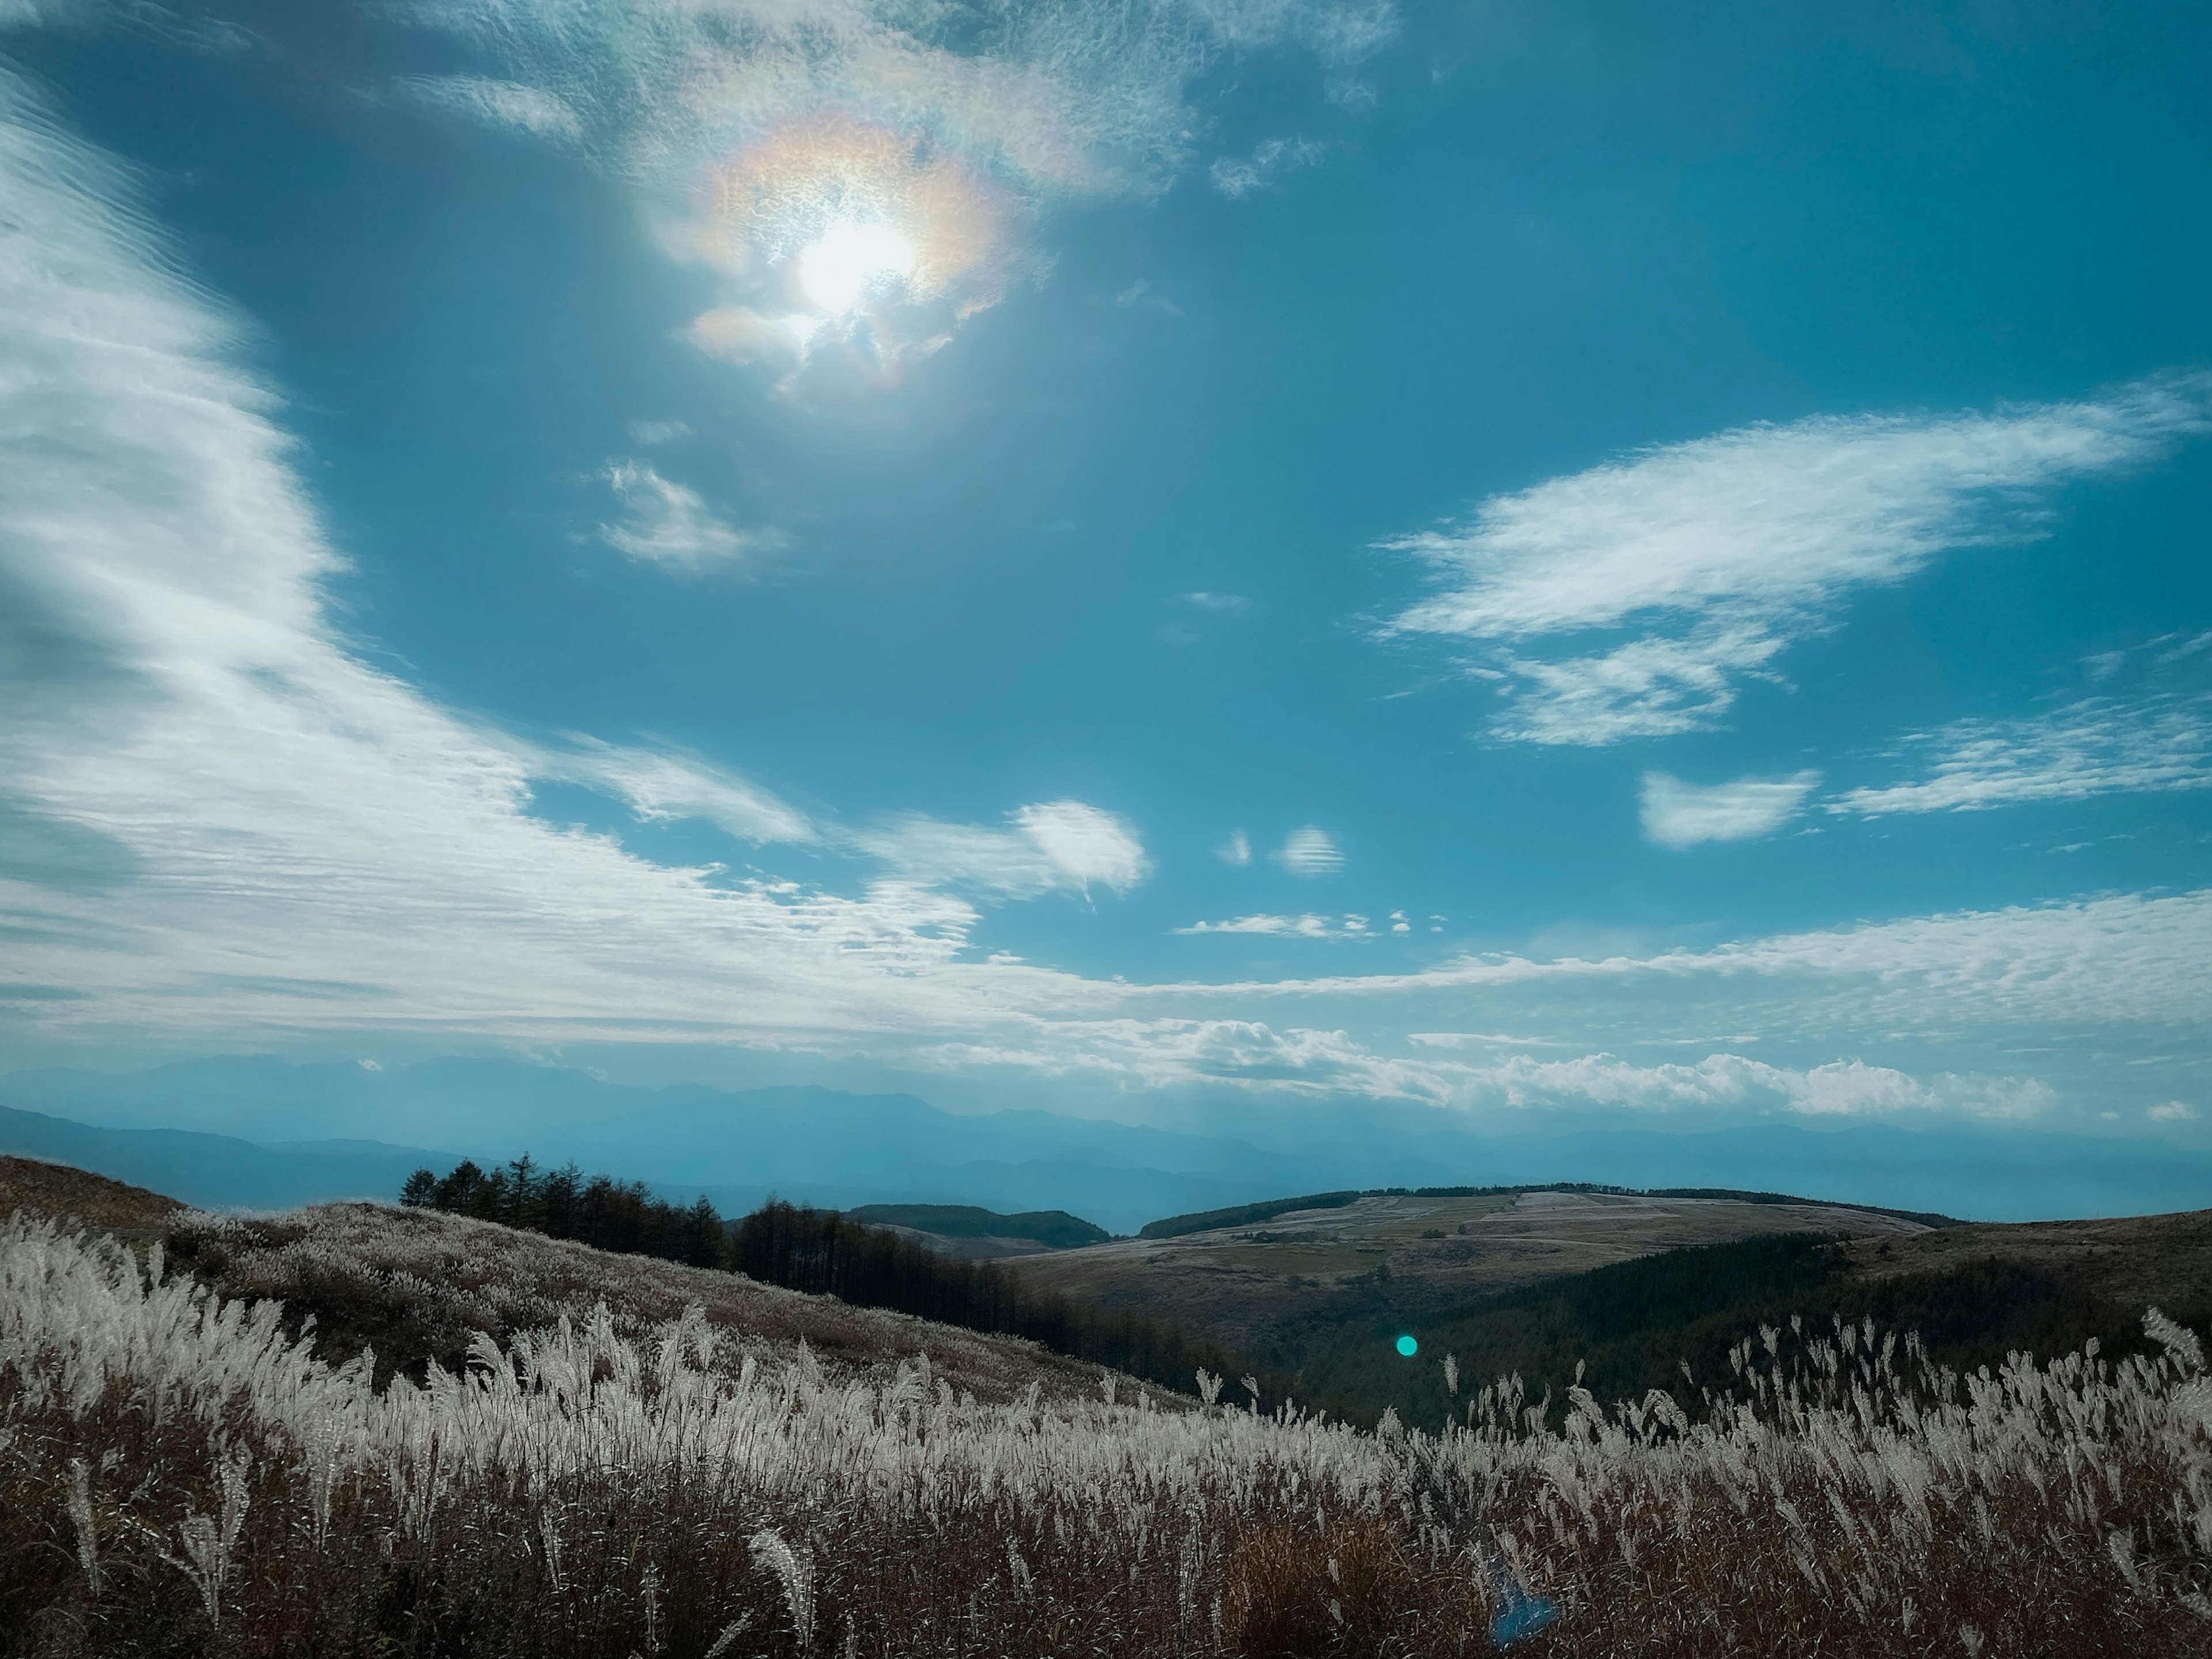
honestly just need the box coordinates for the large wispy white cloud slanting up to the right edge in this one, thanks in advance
[1380,376,2212,743]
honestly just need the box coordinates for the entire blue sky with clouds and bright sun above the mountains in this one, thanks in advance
[0,0,2212,1146]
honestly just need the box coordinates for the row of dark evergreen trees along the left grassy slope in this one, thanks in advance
[400,1157,1241,1393]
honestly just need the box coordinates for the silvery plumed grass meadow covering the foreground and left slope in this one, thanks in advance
[0,1183,2212,1659]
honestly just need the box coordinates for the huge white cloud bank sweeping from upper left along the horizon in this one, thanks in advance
[0,75,2212,1122]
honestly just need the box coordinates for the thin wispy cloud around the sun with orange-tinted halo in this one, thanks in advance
[387,0,1396,365]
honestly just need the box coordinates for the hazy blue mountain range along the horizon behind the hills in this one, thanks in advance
[0,1055,2212,1232]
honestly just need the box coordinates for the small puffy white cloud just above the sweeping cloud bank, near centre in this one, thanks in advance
[851,801,1153,898]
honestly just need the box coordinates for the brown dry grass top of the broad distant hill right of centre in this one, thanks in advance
[1009,1192,1929,1347]
